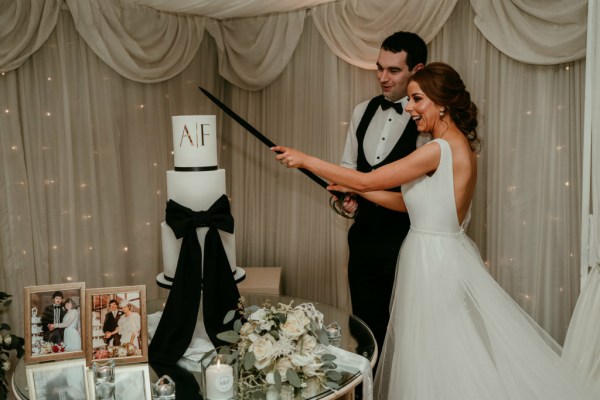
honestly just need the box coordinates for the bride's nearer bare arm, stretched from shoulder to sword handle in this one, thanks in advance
[271,141,441,193]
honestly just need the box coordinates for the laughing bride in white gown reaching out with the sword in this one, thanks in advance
[272,63,600,400]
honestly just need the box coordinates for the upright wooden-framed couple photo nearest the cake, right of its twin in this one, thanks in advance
[85,285,148,365]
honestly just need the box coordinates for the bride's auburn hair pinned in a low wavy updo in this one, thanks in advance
[410,62,481,150]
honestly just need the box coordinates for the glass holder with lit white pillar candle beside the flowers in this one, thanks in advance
[200,347,239,400]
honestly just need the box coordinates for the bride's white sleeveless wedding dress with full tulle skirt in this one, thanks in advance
[373,139,600,400]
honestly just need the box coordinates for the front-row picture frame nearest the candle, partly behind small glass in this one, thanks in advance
[87,364,152,400]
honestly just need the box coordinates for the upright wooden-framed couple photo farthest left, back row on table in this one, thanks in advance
[23,282,86,364]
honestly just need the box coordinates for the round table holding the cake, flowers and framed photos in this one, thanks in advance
[12,293,377,400]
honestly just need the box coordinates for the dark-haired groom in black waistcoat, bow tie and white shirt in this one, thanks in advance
[341,32,427,351]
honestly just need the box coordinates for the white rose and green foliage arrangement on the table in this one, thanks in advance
[217,297,342,389]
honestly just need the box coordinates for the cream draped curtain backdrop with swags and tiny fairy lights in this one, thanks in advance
[0,0,598,350]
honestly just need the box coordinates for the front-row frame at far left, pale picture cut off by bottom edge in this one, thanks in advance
[25,358,90,400]
